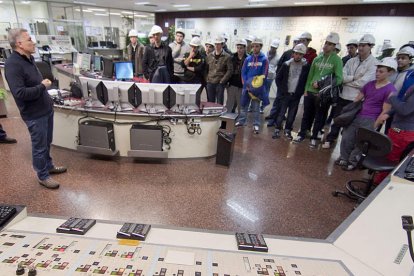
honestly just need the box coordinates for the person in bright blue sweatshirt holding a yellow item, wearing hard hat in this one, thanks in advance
[236,38,269,134]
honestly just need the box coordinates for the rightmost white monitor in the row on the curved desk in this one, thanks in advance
[170,84,203,114]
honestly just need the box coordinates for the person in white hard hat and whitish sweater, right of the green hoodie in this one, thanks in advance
[322,34,378,149]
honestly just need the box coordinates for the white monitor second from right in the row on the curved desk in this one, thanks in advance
[136,83,170,113]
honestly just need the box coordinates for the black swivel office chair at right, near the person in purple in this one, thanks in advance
[332,128,398,202]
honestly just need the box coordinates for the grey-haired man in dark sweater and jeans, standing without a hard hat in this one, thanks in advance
[5,28,66,189]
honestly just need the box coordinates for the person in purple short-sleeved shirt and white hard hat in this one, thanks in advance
[335,57,397,171]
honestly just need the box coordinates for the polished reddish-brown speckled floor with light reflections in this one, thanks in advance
[0,85,361,238]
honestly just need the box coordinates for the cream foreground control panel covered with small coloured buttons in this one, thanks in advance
[0,232,351,276]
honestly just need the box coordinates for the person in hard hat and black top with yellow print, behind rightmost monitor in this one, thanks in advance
[182,37,206,86]
